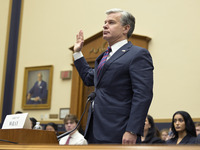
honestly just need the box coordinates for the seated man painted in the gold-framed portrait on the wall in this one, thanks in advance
[27,73,47,104]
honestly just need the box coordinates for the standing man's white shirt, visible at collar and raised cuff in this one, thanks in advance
[73,40,128,60]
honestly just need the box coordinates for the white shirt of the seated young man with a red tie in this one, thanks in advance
[59,131,88,145]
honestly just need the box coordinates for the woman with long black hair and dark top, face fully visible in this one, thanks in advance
[166,111,196,144]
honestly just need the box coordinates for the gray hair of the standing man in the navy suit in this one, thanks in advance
[106,8,135,38]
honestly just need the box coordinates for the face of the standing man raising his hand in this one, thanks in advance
[103,13,129,44]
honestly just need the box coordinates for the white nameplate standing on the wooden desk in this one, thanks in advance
[2,113,31,129]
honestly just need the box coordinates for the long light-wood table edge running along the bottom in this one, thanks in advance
[0,144,200,150]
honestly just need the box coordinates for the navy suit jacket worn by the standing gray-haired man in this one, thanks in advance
[74,42,153,143]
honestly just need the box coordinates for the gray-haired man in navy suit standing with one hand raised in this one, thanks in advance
[73,9,153,144]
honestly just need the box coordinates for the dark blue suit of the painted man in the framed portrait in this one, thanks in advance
[27,81,47,104]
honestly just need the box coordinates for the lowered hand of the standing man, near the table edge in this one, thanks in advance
[122,132,137,145]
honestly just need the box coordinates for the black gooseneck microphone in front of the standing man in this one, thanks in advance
[57,92,96,140]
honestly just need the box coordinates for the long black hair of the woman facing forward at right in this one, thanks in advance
[171,111,196,137]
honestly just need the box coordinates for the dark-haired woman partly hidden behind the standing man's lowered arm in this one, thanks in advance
[141,115,164,144]
